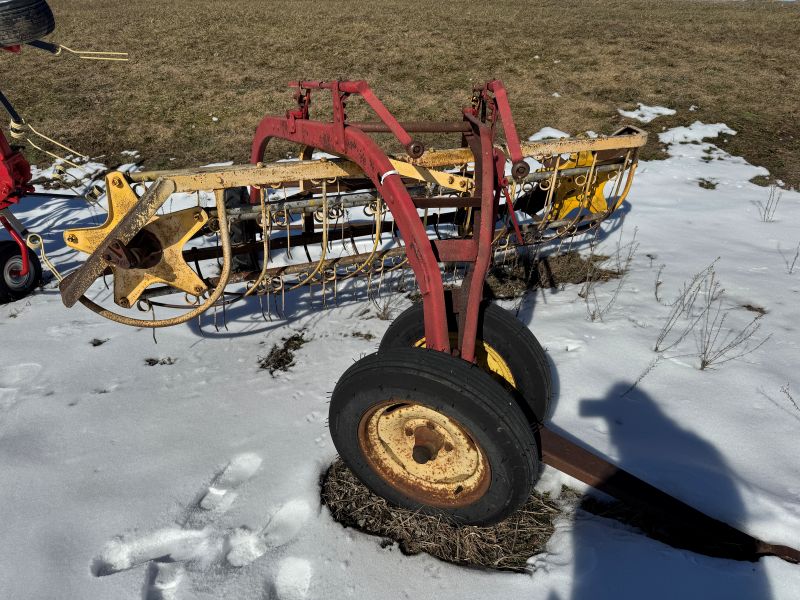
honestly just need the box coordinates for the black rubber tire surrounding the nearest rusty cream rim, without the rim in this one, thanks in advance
[328,348,539,525]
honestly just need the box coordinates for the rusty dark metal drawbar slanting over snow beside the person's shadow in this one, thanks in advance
[538,425,800,563]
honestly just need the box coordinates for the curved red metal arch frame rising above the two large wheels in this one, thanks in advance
[250,81,528,362]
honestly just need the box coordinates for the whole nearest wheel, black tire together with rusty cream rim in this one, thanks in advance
[328,348,539,525]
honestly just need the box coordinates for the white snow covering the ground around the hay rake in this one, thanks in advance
[0,119,800,600]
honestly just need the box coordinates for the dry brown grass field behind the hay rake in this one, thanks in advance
[0,0,800,187]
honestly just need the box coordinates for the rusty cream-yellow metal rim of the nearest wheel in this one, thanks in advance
[358,400,491,508]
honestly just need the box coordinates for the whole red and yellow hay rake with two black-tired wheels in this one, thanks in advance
[14,76,800,562]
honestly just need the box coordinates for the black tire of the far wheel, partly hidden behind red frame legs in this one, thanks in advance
[379,303,552,425]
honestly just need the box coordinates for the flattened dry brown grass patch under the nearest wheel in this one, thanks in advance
[322,459,562,571]
